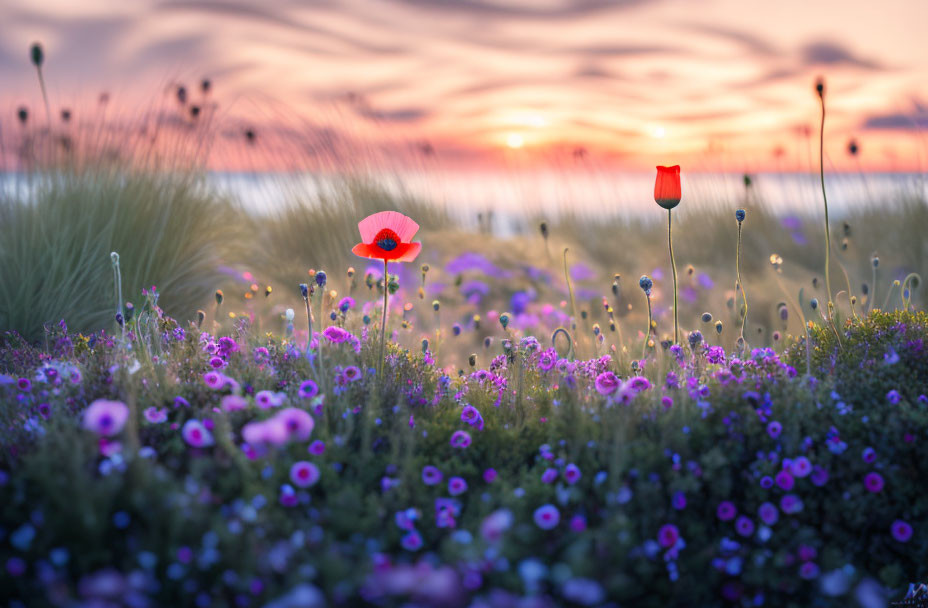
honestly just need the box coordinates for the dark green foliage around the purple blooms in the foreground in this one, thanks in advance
[0,312,928,606]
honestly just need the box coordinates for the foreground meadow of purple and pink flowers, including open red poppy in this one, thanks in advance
[0,197,928,607]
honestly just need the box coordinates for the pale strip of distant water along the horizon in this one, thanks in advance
[0,170,928,234]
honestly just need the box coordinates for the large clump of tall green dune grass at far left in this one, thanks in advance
[0,167,240,340]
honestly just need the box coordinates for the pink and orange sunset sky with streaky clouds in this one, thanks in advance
[0,0,928,171]
